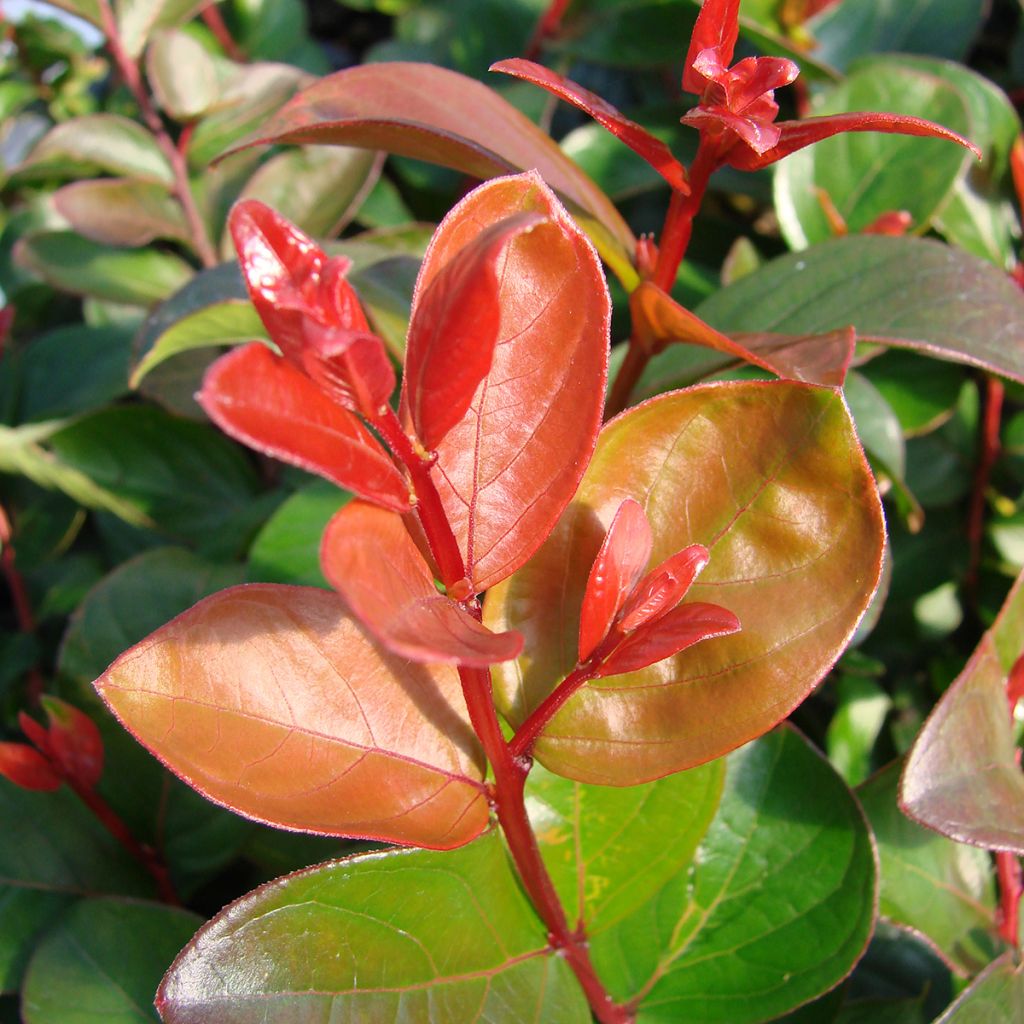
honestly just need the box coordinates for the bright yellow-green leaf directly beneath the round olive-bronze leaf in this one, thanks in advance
[526,760,725,940]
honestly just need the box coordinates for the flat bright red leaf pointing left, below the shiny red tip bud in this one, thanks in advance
[197,343,411,512]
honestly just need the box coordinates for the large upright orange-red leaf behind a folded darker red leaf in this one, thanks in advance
[403,173,610,593]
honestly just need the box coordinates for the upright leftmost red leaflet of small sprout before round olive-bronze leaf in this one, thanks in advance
[580,498,653,662]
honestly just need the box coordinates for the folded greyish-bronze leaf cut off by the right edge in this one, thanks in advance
[900,577,1024,854]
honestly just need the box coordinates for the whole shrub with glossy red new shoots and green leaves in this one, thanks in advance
[0,0,1024,1024]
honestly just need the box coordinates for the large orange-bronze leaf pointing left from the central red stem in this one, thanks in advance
[95,584,487,849]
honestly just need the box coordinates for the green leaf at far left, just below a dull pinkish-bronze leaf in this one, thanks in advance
[14,231,193,306]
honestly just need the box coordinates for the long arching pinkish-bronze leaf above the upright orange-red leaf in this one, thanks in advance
[228,62,635,278]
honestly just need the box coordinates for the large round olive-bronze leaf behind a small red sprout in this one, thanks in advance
[484,381,884,785]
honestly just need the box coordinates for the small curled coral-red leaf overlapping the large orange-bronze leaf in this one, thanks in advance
[321,502,522,667]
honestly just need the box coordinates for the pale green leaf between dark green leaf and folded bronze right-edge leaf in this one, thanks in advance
[857,761,998,976]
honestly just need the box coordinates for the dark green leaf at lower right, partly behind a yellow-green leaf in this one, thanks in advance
[591,727,877,1024]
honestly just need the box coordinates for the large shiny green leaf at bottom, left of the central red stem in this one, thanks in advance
[157,833,591,1024]
